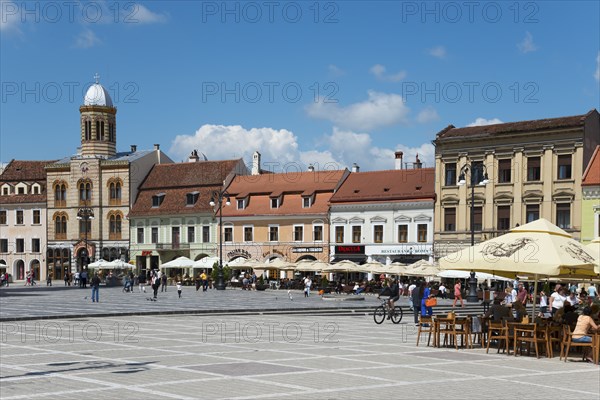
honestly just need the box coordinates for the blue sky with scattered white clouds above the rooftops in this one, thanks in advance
[0,0,600,170]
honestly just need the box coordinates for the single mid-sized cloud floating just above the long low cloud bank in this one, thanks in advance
[306,90,410,131]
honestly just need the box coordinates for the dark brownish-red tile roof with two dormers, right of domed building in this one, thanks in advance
[129,159,242,217]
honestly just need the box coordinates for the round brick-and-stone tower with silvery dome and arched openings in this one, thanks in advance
[79,74,117,158]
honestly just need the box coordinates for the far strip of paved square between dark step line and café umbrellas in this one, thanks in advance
[0,286,420,321]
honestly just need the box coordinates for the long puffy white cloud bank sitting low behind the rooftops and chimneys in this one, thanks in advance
[169,125,435,172]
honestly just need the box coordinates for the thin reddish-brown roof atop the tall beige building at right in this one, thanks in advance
[436,110,595,140]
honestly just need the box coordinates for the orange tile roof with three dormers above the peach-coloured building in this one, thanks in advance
[223,170,349,217]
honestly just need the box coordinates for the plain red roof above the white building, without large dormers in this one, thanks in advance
[330,168,435,204]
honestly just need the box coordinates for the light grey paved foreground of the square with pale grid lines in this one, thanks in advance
[0,314,600,400]
